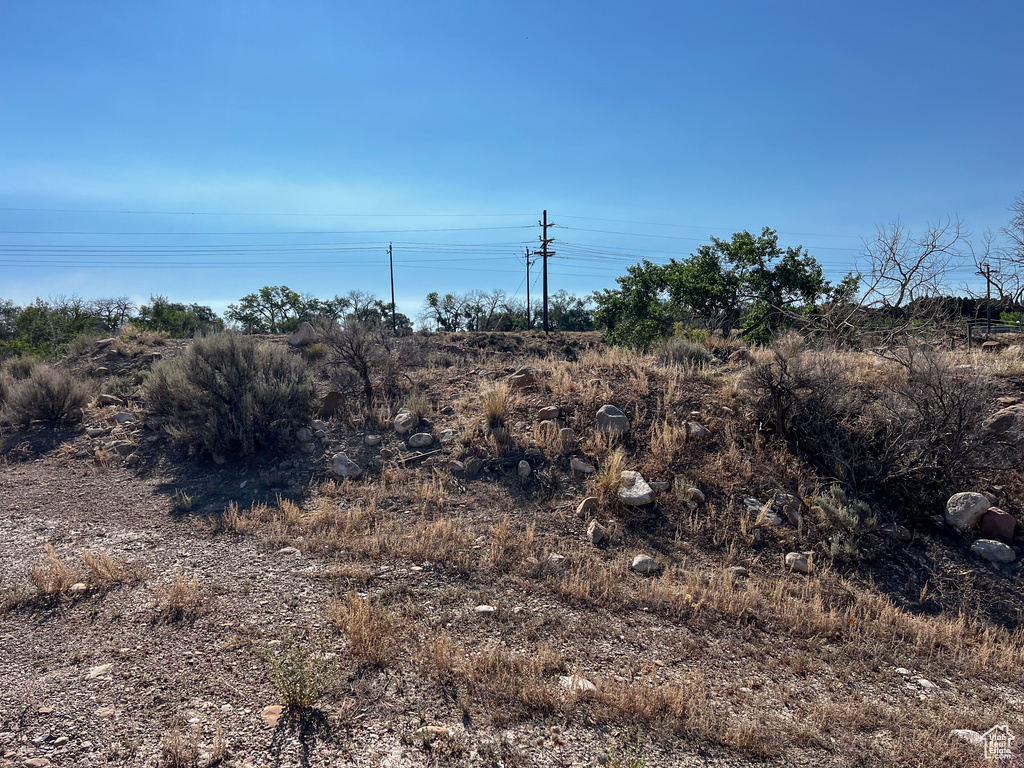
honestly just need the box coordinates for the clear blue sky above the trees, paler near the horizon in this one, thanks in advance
[0,0,1024,315]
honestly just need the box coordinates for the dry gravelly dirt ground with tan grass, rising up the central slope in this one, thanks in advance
[0,335,1024,768]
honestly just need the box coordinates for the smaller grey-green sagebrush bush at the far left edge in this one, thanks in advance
[0,365,92,424]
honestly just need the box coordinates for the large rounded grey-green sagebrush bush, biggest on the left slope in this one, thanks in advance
[143,333,315,456]
